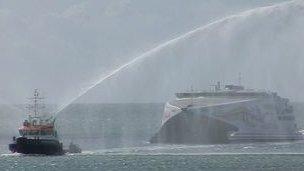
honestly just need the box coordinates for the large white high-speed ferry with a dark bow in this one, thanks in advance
[150,82,303,144]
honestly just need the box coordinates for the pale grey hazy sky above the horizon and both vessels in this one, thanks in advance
[0,0,304,109]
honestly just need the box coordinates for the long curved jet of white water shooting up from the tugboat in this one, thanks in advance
[55,1,303,115]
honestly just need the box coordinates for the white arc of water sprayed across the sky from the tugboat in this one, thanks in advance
[55,1,294,116]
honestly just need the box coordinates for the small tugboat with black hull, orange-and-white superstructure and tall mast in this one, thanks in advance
[9,89,65,155]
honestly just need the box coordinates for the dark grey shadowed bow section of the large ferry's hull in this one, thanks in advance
[150,111,238,144]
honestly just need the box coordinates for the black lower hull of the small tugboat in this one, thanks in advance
[9,137,64,155]
